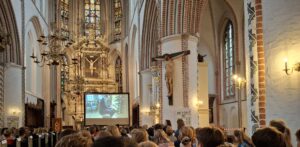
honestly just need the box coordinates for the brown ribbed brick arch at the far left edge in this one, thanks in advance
[0,0,23,65]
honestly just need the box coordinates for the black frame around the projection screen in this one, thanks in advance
[83,92,131,126]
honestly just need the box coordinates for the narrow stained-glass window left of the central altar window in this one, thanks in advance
[60,0,69,36]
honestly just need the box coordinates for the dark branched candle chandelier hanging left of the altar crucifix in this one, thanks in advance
[30,24,78,66]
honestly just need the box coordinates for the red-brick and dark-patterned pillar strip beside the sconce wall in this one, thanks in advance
[244,0,266,134]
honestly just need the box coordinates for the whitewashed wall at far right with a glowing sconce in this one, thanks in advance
[262,0,300,145]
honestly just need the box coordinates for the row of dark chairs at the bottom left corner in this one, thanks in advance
[0,133,58,147]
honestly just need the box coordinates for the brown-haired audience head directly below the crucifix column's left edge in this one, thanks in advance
[154,129,174,147]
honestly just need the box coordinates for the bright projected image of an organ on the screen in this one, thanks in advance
[85,94,128,118]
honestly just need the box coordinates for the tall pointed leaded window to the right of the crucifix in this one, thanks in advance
[224,21,234,98]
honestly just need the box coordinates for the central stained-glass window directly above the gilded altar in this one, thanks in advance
[84,0,101,37]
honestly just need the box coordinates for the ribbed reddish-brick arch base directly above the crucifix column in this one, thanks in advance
[161,0,208,37]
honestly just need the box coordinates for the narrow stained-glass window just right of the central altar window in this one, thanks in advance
[113,0,122,40]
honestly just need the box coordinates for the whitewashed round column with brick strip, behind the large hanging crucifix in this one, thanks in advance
[161,34,203,127]
